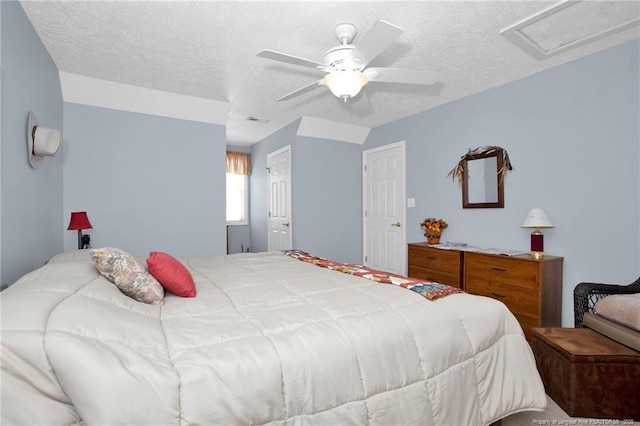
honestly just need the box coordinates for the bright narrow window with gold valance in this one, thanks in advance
[227,151,251,225]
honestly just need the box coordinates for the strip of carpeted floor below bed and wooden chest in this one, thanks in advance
[502,396,640,426]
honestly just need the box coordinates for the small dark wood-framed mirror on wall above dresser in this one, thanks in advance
[462,151,504,209]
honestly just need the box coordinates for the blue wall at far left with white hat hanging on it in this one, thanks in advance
[0,1,65,284]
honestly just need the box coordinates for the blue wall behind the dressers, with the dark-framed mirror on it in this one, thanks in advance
[364,41,640,326]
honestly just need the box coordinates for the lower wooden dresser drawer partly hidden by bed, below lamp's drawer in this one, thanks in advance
[465,277,540,320]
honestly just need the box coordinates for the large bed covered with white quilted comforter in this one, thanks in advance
[0,250,547,425]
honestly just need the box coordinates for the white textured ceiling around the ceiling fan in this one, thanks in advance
[20,0,640,144]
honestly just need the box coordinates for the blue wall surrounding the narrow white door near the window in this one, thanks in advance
[251,120,362,263]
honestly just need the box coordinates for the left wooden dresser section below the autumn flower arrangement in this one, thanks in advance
[408,243,463,288]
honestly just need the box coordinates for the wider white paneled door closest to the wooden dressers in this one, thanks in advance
[363,142,407,275]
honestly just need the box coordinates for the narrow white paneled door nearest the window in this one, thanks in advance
[267,146,293,250]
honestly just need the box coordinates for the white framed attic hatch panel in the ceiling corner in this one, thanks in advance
[500,0,640,59]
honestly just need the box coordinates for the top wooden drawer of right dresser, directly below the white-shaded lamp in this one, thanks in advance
[465,253,540,290]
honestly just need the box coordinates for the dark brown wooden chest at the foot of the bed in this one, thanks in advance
[531,328,640,419]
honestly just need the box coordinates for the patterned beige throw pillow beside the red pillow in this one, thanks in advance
[89,247,164,305]
